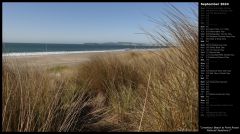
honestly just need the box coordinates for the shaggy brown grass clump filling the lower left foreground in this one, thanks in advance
[2,61,107,132]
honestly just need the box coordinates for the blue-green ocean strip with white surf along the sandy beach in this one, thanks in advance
[2,43,159,56]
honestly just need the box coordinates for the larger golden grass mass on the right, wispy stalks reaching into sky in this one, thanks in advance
[74,4,198,131]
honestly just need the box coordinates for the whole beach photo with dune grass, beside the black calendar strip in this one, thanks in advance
[2,2,199,132]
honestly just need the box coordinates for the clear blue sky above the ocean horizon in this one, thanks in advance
[2,2,198,43]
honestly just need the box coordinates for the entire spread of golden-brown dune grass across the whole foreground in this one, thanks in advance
[2,7,198,132]
